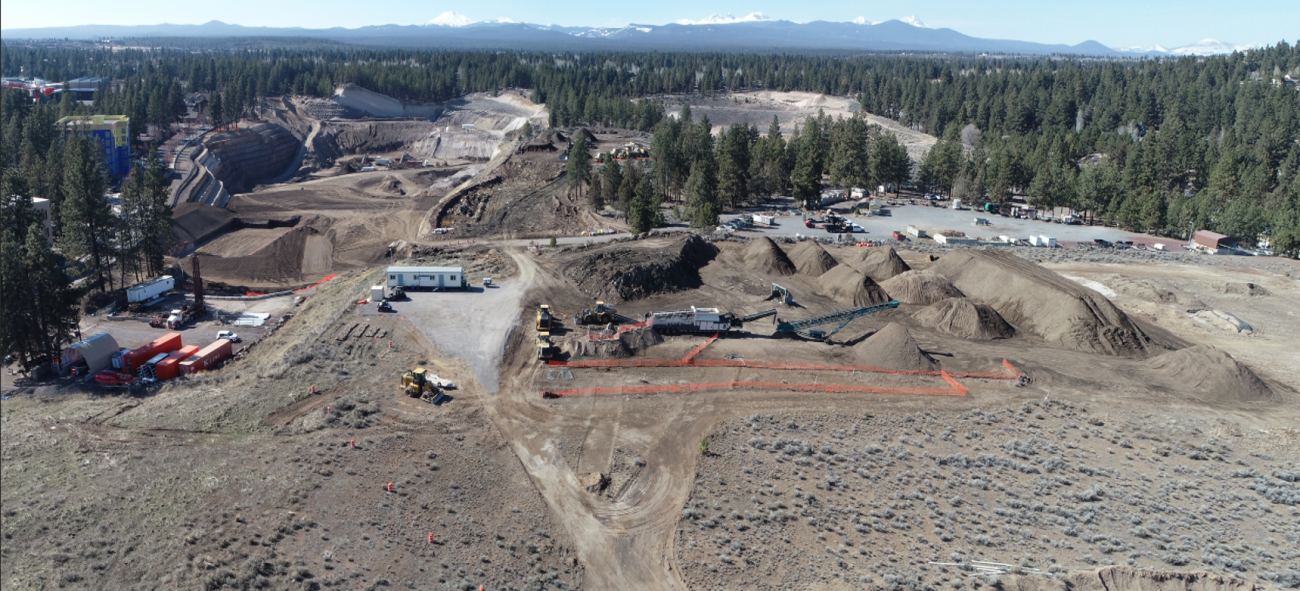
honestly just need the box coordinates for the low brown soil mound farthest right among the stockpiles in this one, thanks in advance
[1147,344,1273,401]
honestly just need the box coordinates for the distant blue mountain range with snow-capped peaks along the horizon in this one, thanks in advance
[3,12,1247,57]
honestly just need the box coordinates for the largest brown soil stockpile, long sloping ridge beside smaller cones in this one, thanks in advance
[928,249,1151,357]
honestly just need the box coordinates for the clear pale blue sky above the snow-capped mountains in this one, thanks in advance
[0,0,1300,47]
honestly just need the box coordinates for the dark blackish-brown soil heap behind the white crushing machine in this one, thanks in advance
[564,234,718,301]
